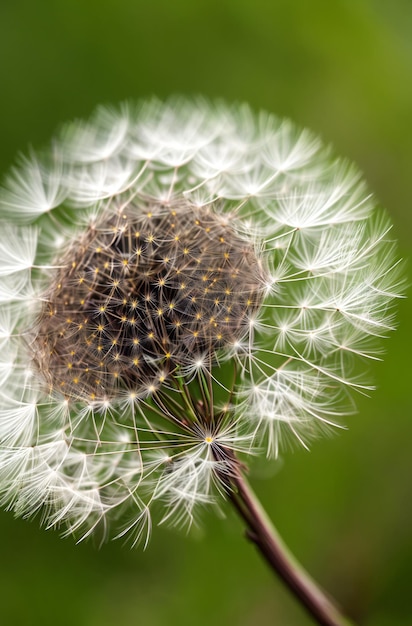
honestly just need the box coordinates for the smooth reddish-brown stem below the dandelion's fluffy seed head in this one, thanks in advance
[229,471,352,626]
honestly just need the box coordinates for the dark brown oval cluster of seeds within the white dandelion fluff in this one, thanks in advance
[32,203,265,401]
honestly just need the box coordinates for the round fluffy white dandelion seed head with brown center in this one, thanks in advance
[0,99,400,623]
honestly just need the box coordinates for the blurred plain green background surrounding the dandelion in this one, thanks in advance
[0,0,412,626]
